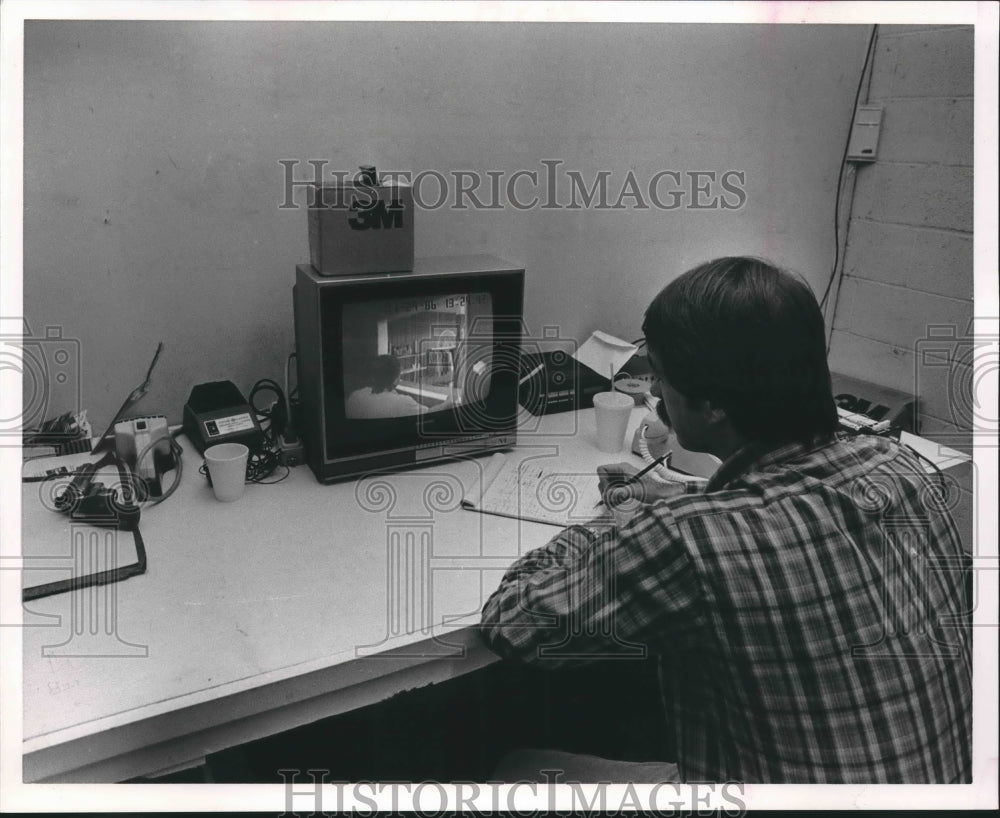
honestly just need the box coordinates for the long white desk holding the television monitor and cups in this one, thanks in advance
[22,409,644,782]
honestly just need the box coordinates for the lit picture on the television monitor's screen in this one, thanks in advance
[341,292,493,420]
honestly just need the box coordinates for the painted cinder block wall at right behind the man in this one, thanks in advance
[830,26,974,550]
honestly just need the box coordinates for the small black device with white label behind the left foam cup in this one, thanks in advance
[184,381,264,454]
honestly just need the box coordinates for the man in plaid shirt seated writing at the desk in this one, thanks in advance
[483,258,972,783]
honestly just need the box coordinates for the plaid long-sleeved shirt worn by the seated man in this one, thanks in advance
[483,430,972,783]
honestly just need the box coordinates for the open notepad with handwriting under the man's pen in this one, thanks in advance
[462,453,611,528]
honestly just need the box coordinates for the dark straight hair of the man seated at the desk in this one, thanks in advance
[642,256,837,444]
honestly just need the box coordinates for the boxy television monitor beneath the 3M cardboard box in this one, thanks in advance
[293,256,524,483]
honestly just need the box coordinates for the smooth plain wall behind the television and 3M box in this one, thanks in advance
[24,21,869,426]
